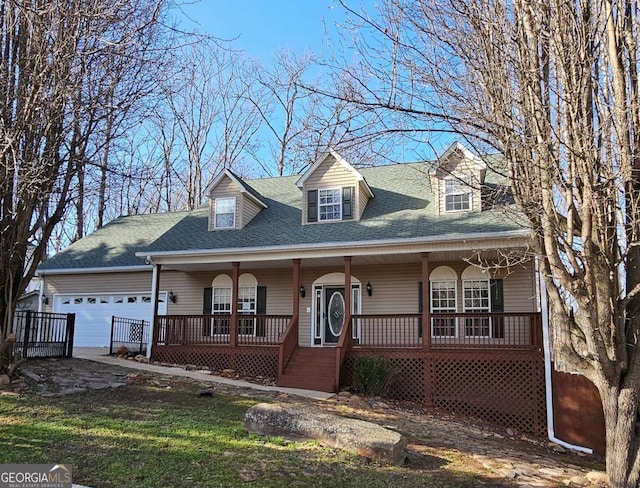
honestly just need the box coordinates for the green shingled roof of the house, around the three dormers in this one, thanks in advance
[39,163,523,272]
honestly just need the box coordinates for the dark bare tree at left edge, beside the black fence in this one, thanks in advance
[0,0,174,371]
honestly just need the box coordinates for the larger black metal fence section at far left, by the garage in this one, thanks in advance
[12,310,76,359]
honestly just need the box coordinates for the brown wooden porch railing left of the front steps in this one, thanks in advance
[157,314,291,346]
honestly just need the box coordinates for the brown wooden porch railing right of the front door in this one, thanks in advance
[351,313,542,349]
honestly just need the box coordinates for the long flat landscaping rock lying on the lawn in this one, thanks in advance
[243,403,407,465]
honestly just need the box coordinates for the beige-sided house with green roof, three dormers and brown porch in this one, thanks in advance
[39,143,546,433]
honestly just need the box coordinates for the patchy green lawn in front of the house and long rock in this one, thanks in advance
[0,383,506,488]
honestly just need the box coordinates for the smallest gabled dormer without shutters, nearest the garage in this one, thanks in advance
[205,169,267,231]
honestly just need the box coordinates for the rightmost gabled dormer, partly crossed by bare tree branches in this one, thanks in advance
[429,142,487,215]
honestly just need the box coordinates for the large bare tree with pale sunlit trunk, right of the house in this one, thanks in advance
[335,0,640,487]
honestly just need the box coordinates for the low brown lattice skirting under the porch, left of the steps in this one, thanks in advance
[153,346,278,378]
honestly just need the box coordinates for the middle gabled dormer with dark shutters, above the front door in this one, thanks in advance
[296,149,373,224]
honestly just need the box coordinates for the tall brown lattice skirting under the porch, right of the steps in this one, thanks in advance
[341,349,546,436]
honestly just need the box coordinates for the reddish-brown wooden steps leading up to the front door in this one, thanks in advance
[278,347,336,393]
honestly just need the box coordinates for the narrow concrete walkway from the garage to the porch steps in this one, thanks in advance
[73,347,334,400]
